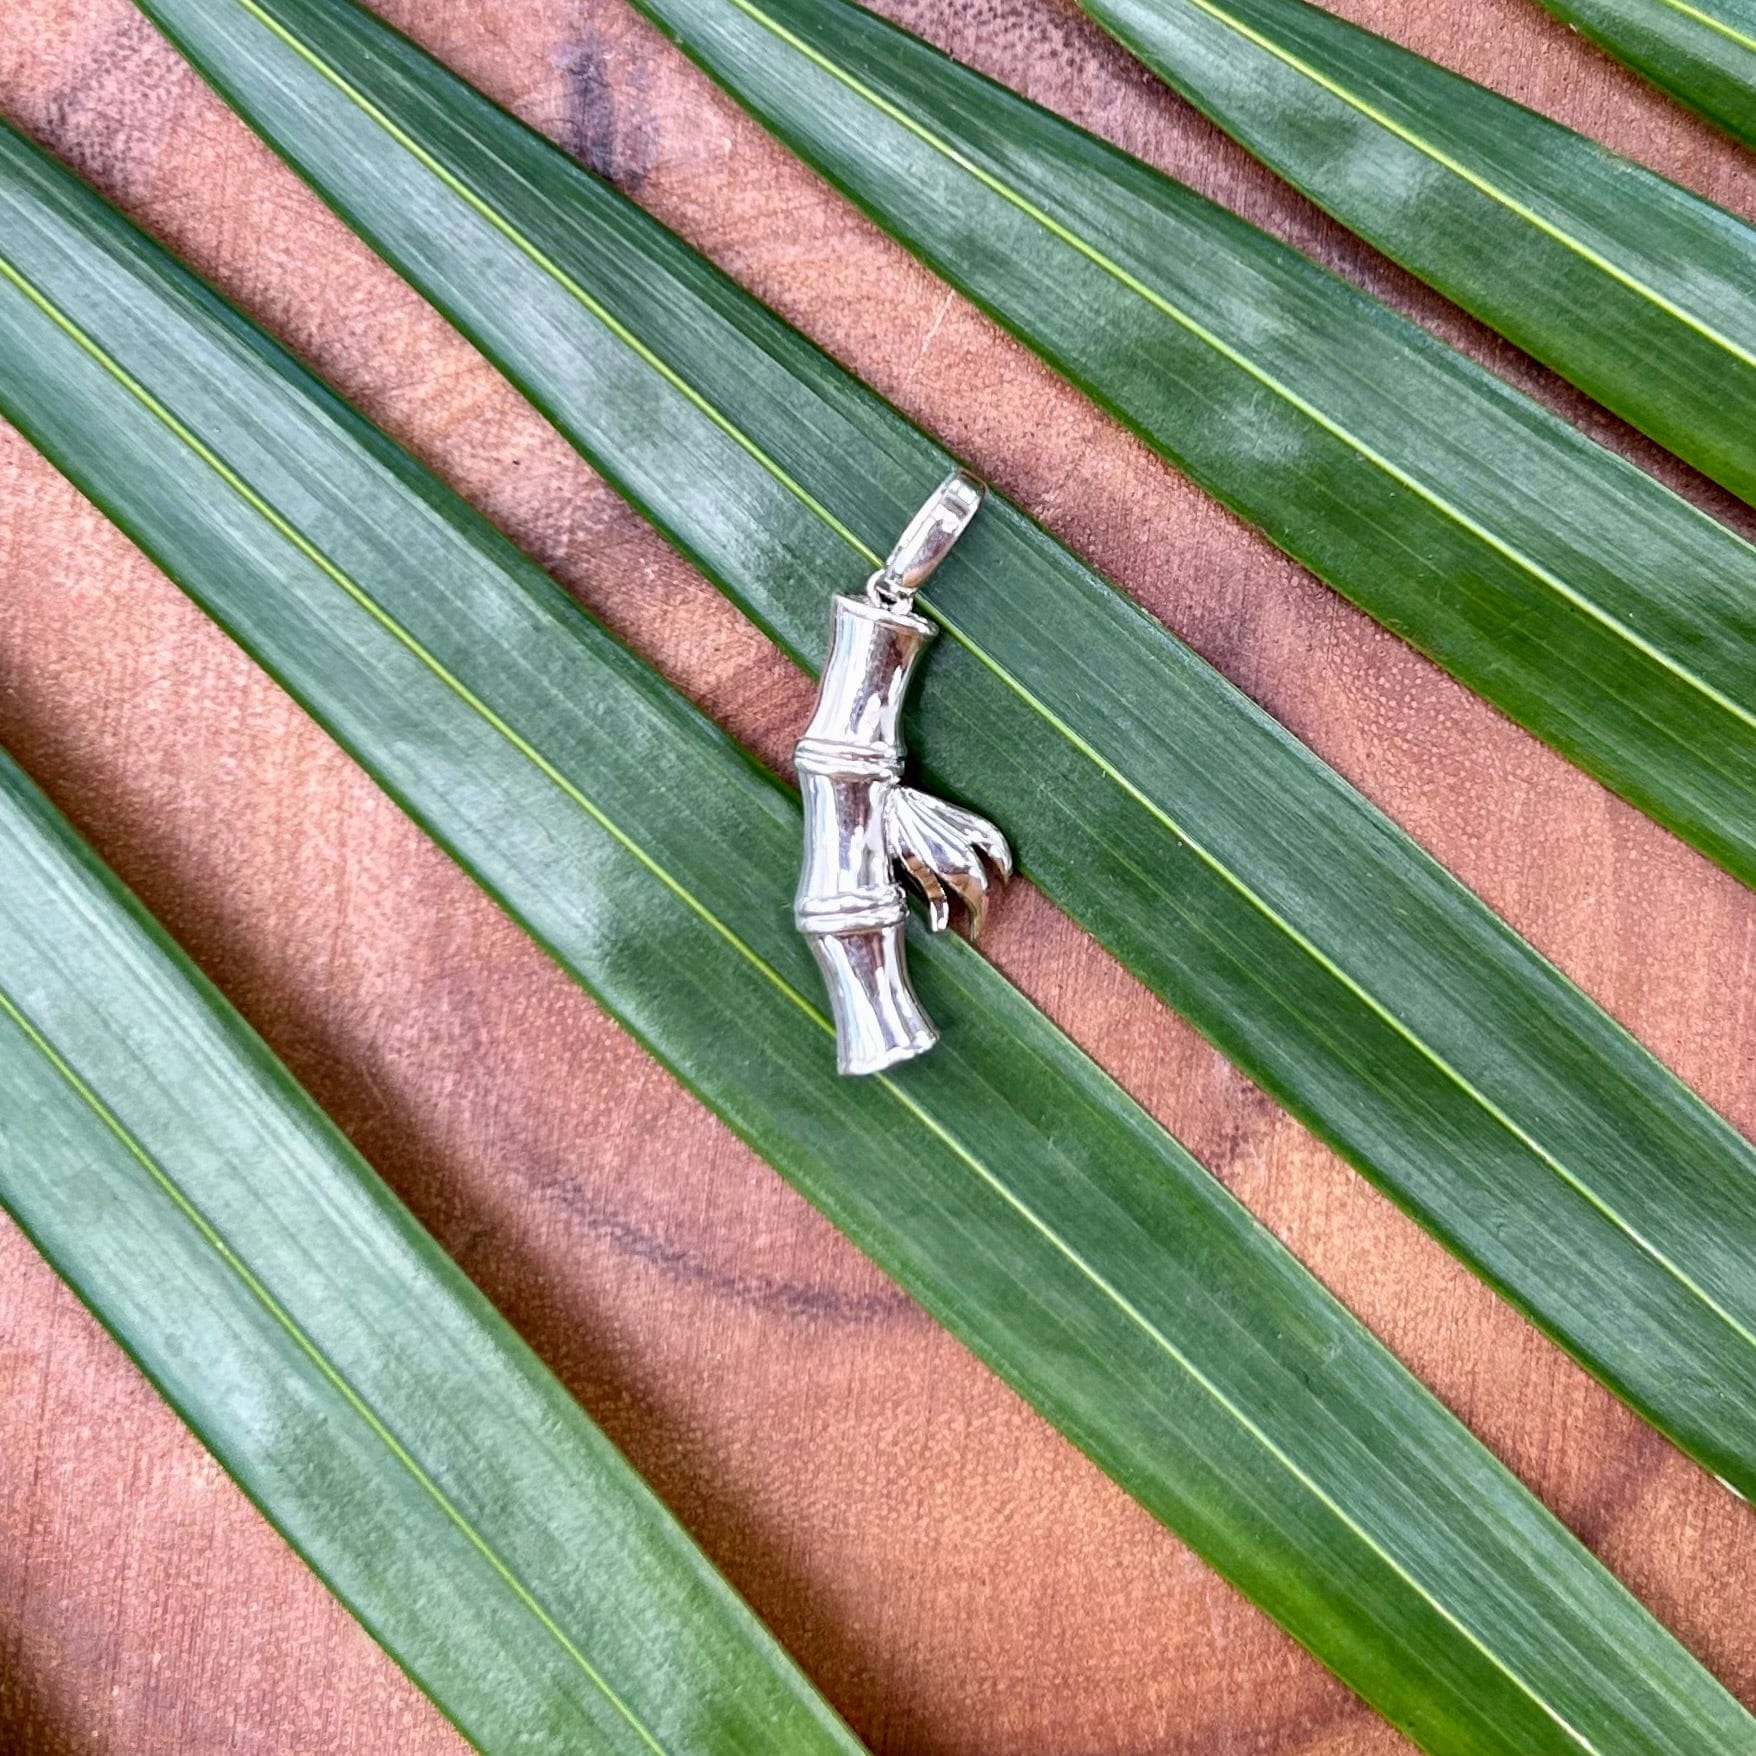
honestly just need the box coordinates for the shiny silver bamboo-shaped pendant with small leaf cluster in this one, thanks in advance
[792,471,1011,1073]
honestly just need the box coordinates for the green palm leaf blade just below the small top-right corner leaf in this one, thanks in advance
[1085,0,1756,500]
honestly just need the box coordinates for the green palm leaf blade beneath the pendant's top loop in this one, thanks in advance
[127,0,1756,1494]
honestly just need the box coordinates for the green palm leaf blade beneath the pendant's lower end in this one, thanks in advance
[0,113,1751,1756]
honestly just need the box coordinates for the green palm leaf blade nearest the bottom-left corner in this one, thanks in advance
[0,757,857,1756]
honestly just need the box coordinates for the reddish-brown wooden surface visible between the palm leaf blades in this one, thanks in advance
[0,0,1756,1756]
